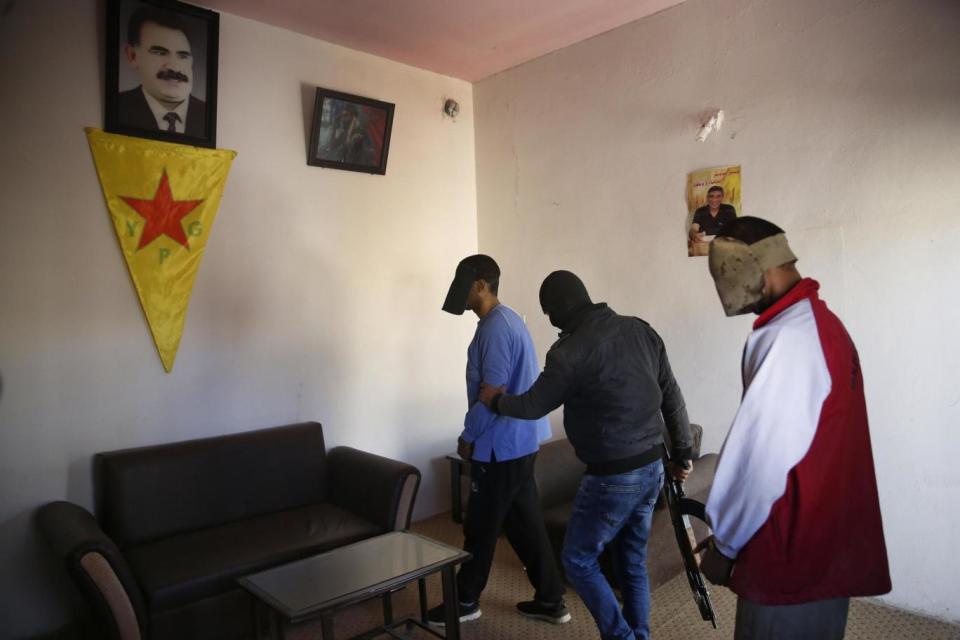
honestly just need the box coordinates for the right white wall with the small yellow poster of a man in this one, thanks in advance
[474,0,960,620]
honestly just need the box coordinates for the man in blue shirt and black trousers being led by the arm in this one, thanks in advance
[428,255,570,625]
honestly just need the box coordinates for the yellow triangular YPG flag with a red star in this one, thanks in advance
[87,128,237,373]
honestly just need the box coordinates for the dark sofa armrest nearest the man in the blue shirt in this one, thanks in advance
[327,447,420,531]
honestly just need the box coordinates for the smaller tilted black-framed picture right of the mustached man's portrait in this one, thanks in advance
[307,87,395,175]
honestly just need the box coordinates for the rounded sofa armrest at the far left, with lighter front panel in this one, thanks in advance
[37,501,147,640]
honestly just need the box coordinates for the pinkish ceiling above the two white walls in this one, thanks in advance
[200,0,683,82]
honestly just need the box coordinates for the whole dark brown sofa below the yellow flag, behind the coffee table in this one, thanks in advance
[38,422,420,640]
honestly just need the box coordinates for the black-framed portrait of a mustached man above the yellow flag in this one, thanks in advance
[103,0,220,148]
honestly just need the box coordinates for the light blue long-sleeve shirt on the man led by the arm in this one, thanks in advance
[461,304,550,462]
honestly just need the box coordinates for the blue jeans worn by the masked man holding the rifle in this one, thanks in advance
[563,460,663,640]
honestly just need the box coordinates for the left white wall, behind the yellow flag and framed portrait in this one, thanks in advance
[0,0,477,637]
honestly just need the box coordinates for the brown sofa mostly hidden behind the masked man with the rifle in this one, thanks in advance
[534,424,717,589]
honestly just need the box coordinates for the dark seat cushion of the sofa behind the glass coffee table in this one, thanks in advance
[126,504,384,612]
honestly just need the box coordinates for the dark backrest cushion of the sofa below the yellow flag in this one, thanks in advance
[94,422,327,550]
